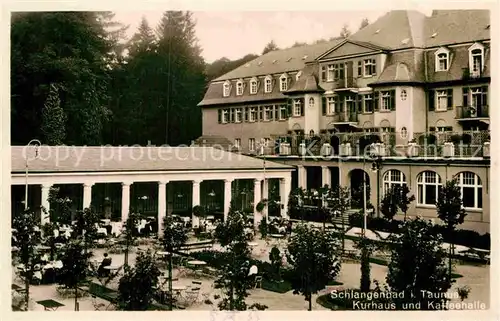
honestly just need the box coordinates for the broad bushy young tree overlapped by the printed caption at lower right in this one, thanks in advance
[386,217,452,310]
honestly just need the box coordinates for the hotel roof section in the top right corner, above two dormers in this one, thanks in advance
[425,10,490,47]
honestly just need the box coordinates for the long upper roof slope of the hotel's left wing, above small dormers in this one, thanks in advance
[214,38,343,81]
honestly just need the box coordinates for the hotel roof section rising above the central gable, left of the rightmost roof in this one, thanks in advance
[349,10,426,50]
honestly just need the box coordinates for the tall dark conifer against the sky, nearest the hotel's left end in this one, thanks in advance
[152,11,205,145]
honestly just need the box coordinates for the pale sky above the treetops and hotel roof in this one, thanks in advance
[115,10,410,63]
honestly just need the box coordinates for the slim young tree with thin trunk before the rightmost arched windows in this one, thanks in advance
[436,180,467,277]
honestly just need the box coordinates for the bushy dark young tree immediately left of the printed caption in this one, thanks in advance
[287,224,341,311]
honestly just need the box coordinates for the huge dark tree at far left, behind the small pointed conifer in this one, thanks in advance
[11,12,117,145]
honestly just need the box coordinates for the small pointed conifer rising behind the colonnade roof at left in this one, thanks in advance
[41,84,67,145]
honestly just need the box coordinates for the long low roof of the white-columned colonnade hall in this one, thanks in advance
[11,146,292,173]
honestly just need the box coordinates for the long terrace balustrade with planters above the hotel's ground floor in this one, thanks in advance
[264,131,490,158]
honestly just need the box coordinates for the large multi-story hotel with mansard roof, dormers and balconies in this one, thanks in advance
[197,10,491,232]
